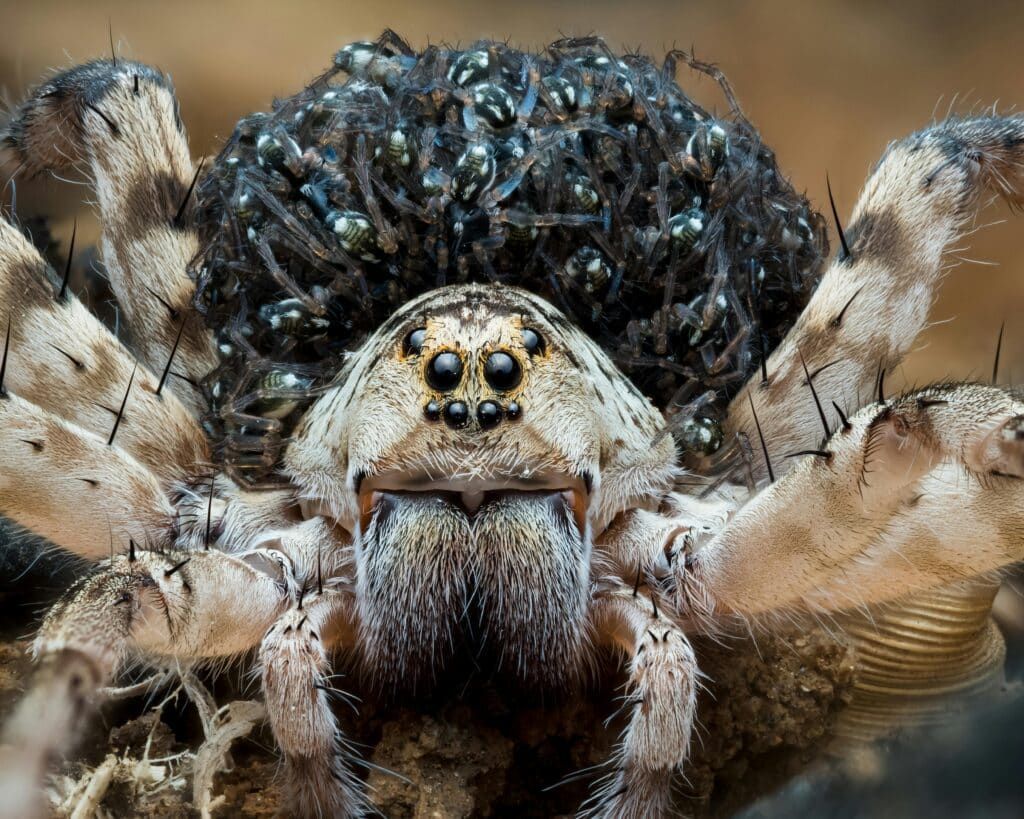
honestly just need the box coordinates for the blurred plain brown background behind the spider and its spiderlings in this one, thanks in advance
[0,0,1024,382]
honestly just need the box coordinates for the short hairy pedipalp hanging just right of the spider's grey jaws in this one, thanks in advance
[583,580,700,818]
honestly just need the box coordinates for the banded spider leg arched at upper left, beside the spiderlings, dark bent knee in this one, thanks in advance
[6,60,214,411]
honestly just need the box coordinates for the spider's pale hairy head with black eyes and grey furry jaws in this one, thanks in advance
[285,285,677,682]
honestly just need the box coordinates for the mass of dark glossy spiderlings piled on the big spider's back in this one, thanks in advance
[197,32,826,487]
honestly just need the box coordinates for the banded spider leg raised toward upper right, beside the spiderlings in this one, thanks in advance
[726,116,1024,478]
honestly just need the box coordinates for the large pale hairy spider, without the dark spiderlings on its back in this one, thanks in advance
[0,46,1024,817]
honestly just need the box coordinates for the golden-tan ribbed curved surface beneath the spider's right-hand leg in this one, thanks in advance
[836,580,1006,745]
